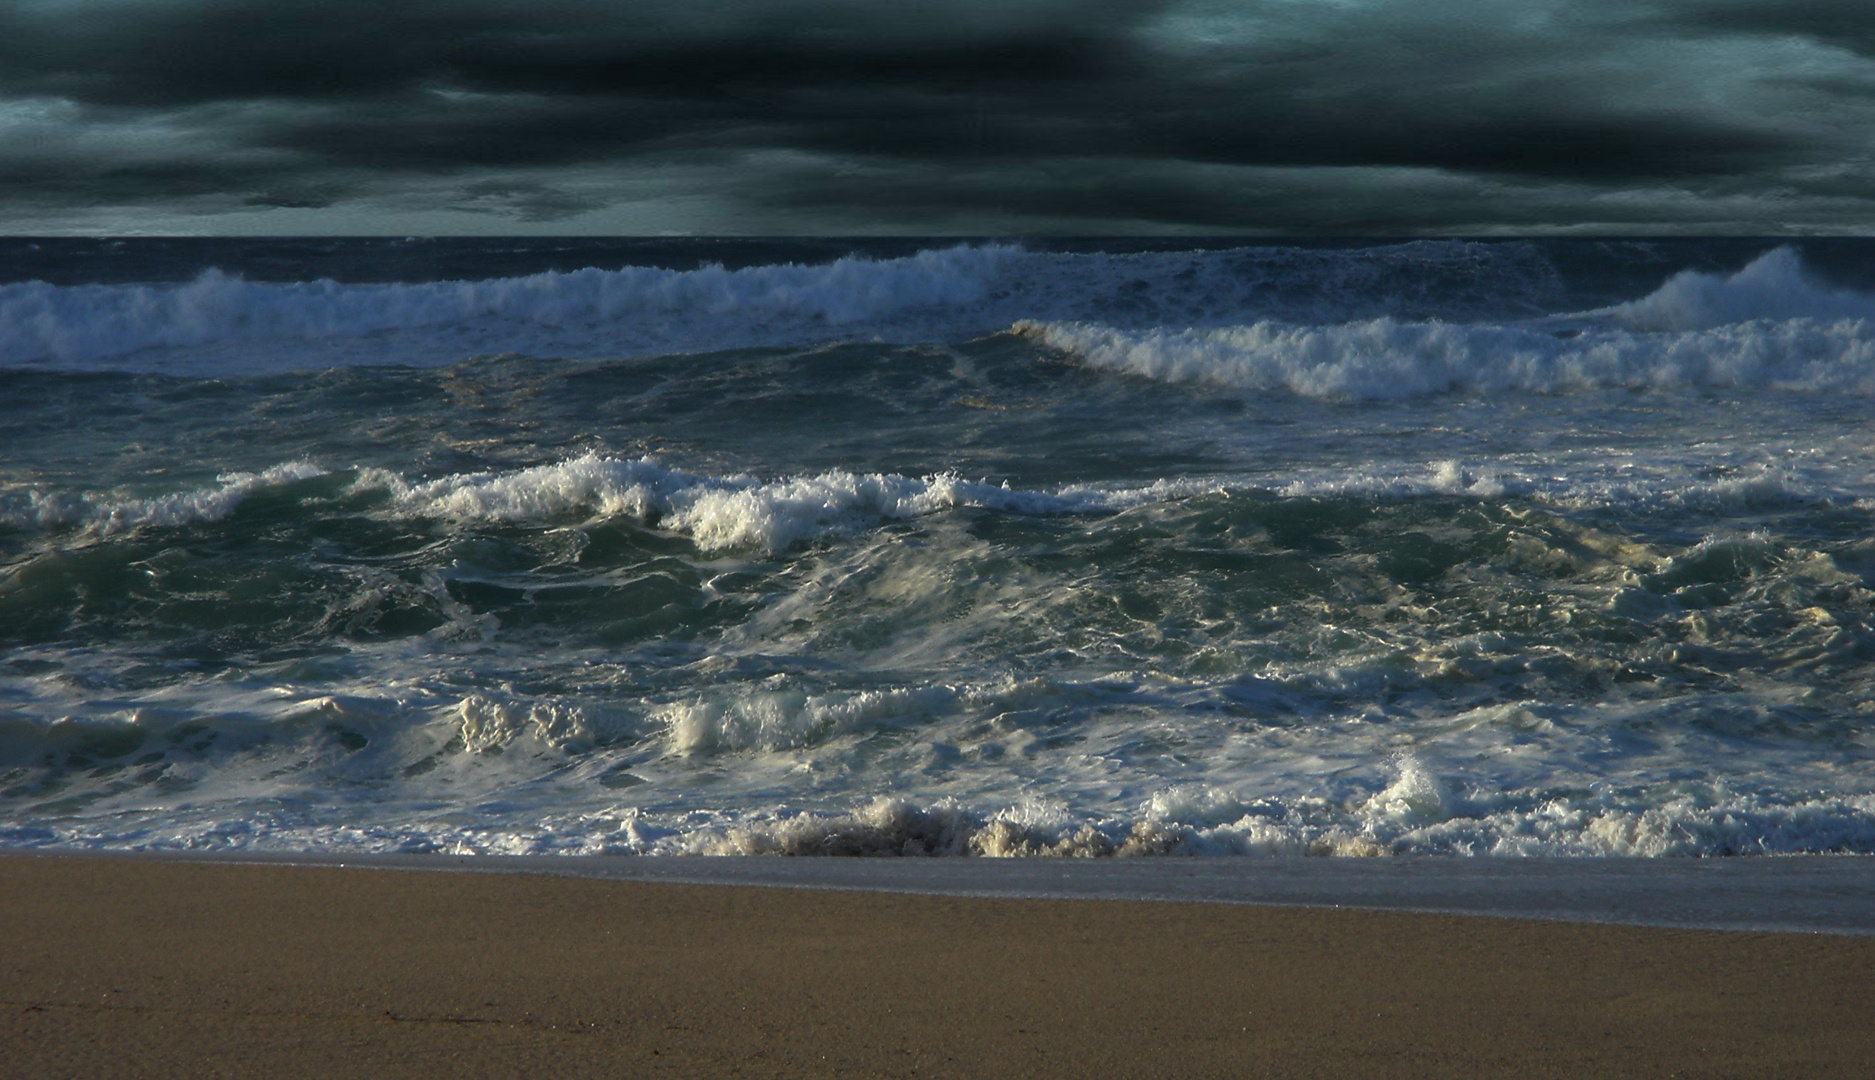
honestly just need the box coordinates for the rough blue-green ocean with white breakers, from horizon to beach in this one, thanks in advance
[0,238,1875,857]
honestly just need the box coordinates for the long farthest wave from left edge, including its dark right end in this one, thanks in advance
[0,240,1554,375]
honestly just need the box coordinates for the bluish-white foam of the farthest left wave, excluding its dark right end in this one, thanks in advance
[0,246,1020,371]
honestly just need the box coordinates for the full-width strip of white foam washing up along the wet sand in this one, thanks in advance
[18,783,1875,859]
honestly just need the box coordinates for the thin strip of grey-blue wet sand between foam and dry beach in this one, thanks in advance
[0,849,1875,936]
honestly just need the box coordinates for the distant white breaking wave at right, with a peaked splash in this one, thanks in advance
[1013,248,1875,399]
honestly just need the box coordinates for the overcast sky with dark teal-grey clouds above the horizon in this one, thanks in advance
[0,0,1875,234]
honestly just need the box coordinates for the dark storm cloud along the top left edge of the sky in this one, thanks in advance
[0,0,1153,105]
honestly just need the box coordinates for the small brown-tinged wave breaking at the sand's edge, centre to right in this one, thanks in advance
[690,776,1875,859]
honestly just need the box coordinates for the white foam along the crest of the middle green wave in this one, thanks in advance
[0,454,1868,553]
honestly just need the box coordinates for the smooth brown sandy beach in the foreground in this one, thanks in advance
[0,855,1875,1080]
